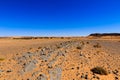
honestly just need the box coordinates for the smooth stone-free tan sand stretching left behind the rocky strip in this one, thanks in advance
[0,39,68,56]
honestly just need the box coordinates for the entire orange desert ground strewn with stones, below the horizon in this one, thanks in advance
[0,38,120,80]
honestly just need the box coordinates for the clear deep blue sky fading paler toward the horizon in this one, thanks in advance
[0,0,120,36]
